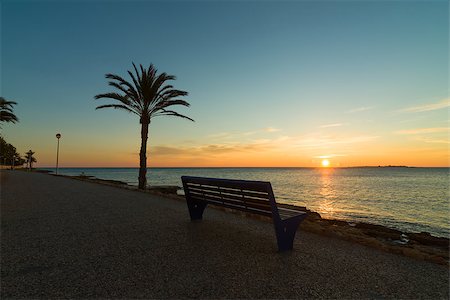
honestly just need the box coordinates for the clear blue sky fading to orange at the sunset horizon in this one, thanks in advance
[0,0,450,167]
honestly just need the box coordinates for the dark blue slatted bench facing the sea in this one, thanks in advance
[181,176,307,251]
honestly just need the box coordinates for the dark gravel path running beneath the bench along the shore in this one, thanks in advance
[0,171,449,299]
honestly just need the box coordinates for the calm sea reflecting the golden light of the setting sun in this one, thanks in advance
[43,168,450,237]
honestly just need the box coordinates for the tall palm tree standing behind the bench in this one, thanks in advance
[95,63,194,189]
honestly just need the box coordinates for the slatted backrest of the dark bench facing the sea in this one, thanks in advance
[181,176,279,218]
